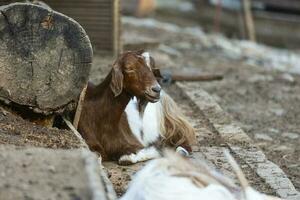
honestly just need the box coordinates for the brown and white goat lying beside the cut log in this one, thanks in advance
[78,51,195,164]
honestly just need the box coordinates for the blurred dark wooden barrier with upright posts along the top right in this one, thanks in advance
[122,0,300,49]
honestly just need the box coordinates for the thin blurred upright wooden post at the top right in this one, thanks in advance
[243,0,256,42]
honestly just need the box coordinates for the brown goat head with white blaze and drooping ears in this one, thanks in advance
[110,51,161,102]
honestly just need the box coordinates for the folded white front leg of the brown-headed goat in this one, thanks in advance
[119,146,160,165]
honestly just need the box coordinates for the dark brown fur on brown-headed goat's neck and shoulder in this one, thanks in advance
[78,73,142,160]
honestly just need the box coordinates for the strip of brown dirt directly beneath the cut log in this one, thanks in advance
[0,107,80,149]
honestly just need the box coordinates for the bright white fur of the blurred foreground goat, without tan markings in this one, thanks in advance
[121,160,236,200]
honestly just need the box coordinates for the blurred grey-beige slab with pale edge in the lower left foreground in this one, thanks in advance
[0,145,115,200]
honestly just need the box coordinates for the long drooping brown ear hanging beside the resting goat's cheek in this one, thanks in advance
[110,60,124,97]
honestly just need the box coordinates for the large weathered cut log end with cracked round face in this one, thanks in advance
[0,3,93,115]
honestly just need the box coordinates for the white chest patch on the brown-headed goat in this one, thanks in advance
[125,97,160,146]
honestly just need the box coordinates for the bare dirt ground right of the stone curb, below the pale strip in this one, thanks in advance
[123,17,300,190]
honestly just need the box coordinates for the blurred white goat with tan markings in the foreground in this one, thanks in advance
[120,151,280,200]
